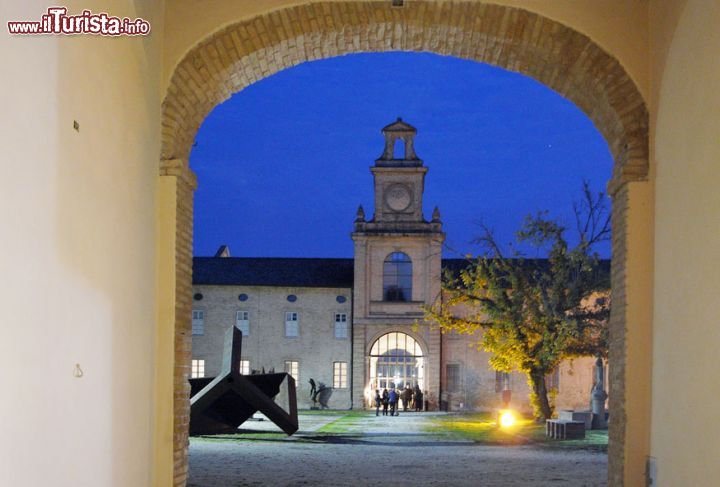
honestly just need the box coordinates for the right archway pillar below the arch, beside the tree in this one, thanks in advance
[608,178,654,486]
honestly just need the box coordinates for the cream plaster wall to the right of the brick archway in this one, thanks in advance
[651,0,720,486]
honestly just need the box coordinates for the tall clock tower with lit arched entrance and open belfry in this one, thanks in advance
[352,118,445,407]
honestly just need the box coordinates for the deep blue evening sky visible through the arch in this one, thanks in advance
[190,52,612,257]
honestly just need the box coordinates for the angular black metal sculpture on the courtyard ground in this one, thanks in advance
[190,327,298,435]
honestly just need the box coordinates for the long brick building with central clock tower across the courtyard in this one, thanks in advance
[192,119,593,410]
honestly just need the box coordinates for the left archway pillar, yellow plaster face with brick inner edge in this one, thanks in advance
[153,159,197,486]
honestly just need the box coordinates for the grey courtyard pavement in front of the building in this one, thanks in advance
[188,412,607,487]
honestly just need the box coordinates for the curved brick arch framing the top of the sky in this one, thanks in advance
[162,1,648,180]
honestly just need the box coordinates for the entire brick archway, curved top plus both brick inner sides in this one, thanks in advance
[160,1,649,485]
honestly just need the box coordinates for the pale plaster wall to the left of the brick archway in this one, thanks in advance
[0,0,163,487]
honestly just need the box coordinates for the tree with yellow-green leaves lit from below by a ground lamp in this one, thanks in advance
[425,183,610,420]
